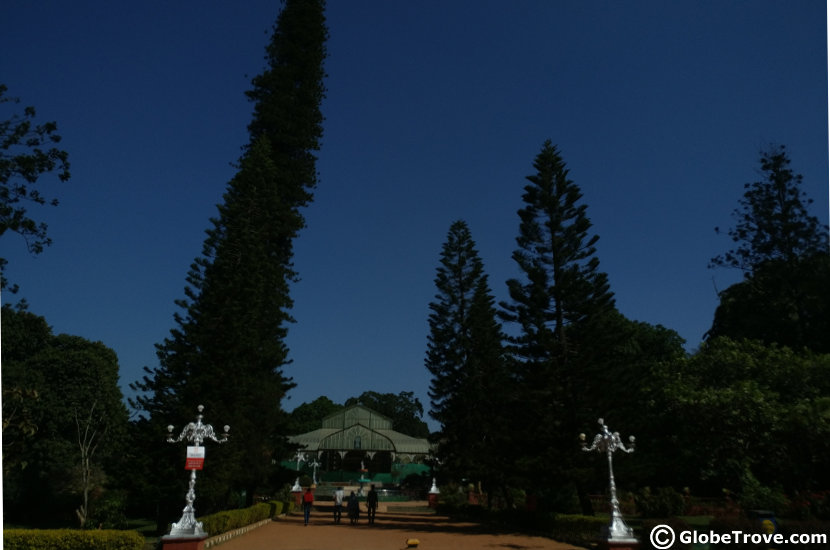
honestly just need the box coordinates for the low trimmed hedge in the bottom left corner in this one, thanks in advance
[3,529,144,550]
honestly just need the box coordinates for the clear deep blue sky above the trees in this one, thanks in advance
[0,0,828,426]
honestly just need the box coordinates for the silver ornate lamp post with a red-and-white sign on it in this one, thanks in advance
[167,405,231,537]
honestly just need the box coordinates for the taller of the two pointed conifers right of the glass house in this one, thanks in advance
[501,141,614,492]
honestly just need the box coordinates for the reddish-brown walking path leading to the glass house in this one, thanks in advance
[216,503,579,550]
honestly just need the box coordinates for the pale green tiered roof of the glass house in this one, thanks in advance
[288,405,429,455]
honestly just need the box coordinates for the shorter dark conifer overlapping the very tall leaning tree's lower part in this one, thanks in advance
[138,138,304,509]
